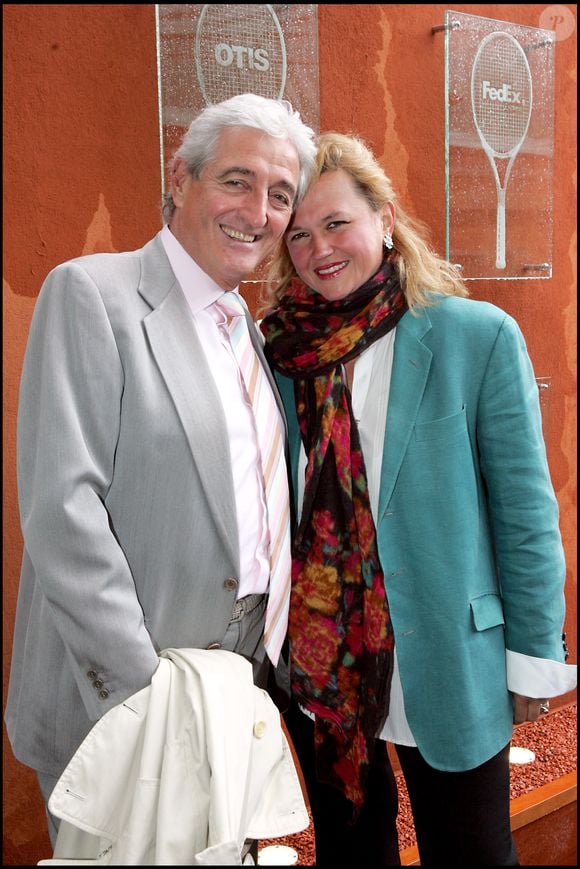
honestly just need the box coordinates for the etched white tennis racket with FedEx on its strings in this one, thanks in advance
[471,31,532,269]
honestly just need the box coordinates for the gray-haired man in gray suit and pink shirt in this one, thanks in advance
[6,94,315,842]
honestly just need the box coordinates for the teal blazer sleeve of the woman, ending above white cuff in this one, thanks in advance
[477,315,566,661]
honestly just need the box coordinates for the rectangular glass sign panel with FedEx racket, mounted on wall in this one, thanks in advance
[445,11,556,280]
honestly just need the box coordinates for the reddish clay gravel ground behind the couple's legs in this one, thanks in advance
[259,703,577,866]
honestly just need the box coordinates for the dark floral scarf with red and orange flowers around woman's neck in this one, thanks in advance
[261,258,407,815]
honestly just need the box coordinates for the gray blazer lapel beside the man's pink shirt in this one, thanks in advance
[139,237,239,564]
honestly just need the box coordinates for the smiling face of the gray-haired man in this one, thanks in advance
[169,127,299,290]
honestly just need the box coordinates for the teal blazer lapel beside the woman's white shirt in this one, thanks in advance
[378,309,433,521]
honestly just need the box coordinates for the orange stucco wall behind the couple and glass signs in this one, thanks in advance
[3,4,577,865]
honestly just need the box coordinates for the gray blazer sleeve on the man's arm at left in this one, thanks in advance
[17,262,159,720]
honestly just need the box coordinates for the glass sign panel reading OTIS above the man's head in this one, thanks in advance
[155,3,320,194]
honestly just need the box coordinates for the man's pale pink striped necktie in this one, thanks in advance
[215,292,291,665]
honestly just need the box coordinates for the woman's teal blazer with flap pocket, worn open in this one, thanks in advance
[277,297,565,771]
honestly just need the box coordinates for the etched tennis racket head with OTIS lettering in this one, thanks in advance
[195,3,286,103]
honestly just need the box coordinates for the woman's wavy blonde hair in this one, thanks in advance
[264,133,468,309]
